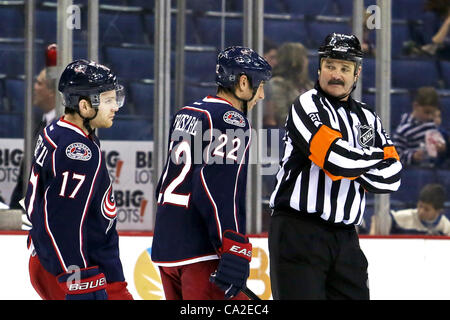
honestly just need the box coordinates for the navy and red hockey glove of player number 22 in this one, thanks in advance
[209,230,252,299]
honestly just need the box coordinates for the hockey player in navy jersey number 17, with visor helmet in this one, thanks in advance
[25,60,132,300]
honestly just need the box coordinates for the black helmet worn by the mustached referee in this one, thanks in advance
[318,33,363,74]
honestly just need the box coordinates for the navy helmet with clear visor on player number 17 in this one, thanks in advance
[58,59,125,110]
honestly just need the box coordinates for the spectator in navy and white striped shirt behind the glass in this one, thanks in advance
[393,87,447,166]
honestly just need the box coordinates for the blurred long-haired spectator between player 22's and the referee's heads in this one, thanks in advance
[264,42,314,127]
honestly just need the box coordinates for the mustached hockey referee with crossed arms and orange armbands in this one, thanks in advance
[269,33,402,300]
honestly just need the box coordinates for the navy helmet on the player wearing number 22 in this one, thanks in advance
[216,46,272,90]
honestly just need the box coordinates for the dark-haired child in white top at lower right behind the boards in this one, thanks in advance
[371,184,450,236]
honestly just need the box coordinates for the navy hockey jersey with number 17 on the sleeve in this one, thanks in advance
[25,118,124,282]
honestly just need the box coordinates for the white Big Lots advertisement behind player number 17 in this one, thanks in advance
[0,139,153,230]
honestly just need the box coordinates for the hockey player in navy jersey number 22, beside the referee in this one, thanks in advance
[152,47,271,300]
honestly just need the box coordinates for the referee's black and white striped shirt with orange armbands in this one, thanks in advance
[270,85,402,225]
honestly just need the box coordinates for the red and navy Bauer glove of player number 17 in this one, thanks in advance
[57,267,108,300]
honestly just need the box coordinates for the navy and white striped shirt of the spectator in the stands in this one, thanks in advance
[392,113,437,165]
